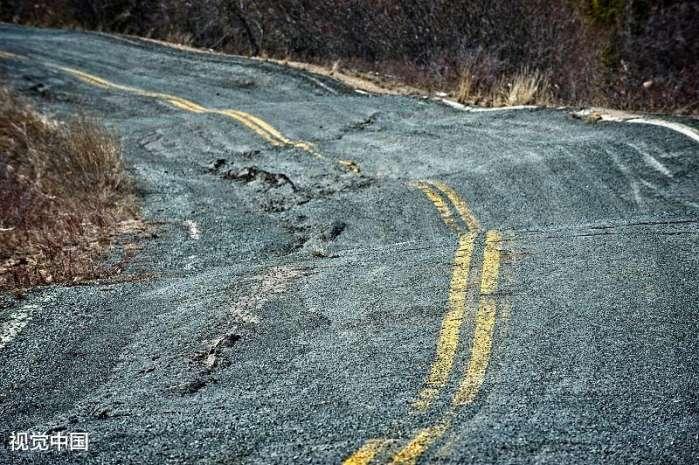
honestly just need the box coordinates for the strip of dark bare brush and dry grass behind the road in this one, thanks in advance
[0,0,699,114]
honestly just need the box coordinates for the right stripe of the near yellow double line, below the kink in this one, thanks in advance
[452,231,502,405]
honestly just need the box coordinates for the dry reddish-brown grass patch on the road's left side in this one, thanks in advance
[0,86,139,289]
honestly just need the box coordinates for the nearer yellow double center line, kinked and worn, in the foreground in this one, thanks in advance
[343,181,502,465]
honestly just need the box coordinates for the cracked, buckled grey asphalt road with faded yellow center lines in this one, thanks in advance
[0,25,699,465]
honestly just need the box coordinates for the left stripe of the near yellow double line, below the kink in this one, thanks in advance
[413,232,477,411]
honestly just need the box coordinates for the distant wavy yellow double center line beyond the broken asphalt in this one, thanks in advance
[0,50,359,172]
